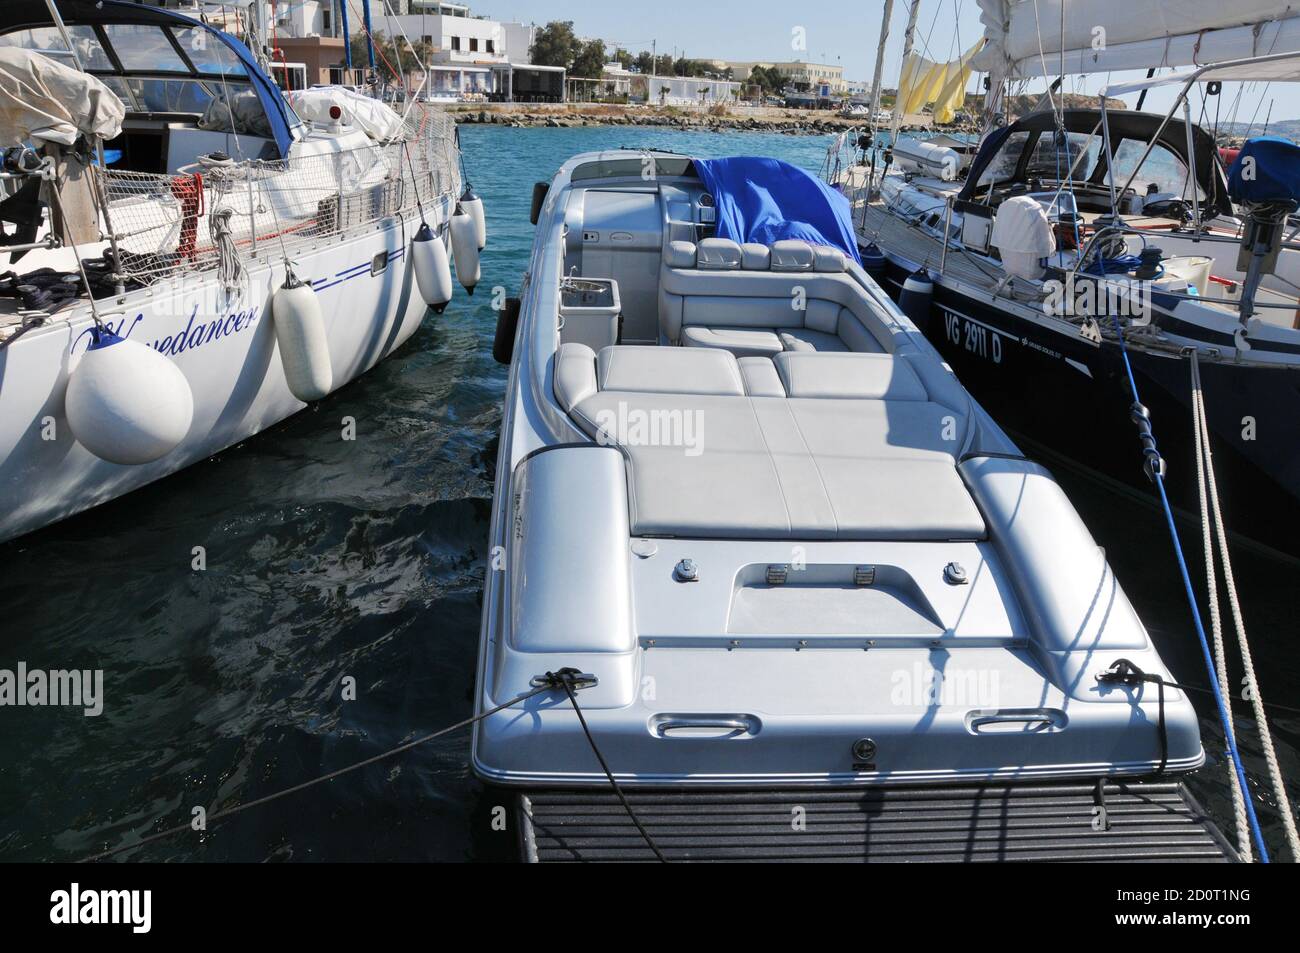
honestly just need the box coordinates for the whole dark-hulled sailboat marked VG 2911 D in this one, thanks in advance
[827,0,1300,554]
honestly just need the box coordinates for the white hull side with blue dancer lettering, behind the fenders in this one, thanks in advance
[0,217,426,541]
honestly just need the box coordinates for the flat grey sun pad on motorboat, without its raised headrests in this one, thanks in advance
[572,393,985,540]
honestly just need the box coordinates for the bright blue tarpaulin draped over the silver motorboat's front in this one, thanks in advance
[696,156,862,265]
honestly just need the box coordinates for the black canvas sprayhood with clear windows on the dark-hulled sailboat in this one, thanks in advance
[958,109,1232,215]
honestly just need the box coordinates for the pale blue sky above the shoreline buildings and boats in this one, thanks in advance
[471,0,1300,125]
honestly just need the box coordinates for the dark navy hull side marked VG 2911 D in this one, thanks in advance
[883,252,1300,558]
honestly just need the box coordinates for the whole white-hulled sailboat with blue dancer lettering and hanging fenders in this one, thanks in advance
[0,0,481,541]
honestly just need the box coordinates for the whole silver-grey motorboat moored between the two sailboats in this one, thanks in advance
[472,151,1231,861]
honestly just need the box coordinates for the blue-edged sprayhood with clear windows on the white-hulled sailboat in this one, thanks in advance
[0,0,302,156]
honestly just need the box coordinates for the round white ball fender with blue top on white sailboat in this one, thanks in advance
[64,328,194,465]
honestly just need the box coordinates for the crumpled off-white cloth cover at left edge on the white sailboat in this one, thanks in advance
[0,47,126,146]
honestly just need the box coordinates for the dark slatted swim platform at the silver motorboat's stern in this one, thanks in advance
[519,780,1238,863]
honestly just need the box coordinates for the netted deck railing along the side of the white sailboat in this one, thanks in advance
[95,104,462,289]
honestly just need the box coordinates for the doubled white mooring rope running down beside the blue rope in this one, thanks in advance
[1191,350,1300,862]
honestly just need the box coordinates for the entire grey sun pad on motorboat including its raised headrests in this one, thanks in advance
[555,345,985,540]
